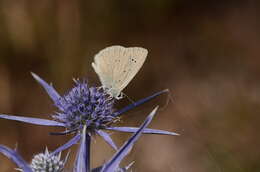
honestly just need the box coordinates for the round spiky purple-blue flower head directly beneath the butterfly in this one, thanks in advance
[53,80,115,132]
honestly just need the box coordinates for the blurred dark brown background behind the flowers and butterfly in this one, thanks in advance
[0,0,260,172]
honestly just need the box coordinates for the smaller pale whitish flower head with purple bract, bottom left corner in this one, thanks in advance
[0,145,68,172]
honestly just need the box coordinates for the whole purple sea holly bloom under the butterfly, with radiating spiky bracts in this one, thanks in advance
[0,73,178,171]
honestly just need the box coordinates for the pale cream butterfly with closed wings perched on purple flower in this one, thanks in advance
[92,45,148,100]
